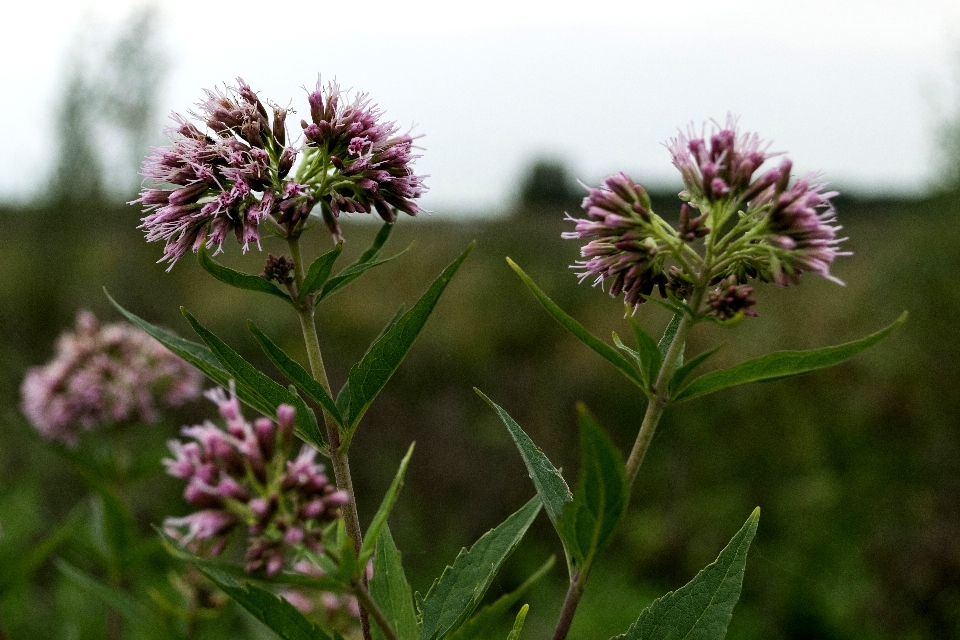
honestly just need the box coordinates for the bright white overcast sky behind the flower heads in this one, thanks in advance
[0,0,960,209]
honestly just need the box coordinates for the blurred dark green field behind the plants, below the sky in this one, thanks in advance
[0,196,960,640]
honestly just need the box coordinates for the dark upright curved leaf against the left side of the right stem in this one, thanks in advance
[557,404,630,578]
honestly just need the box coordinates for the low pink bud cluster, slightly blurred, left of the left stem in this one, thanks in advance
[163,389,347,575]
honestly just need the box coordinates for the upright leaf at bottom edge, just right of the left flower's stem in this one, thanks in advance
[367,526,419,640]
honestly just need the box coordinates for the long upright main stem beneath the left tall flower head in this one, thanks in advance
[287,237,371,640]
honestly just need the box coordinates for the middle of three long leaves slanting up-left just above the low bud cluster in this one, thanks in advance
[180,307,326,451]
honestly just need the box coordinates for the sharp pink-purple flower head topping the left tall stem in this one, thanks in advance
[134,78,426,267]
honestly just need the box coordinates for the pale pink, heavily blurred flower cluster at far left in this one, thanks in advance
[20,311,202,446]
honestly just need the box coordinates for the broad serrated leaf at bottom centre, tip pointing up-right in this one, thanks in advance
[417,498,541,640]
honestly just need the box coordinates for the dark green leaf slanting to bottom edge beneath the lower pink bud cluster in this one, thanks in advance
[191,565,331,640]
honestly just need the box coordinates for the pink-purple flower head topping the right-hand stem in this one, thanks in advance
[563,117,849,319]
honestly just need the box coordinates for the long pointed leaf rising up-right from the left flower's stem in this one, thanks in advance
[346,242,476,440]
